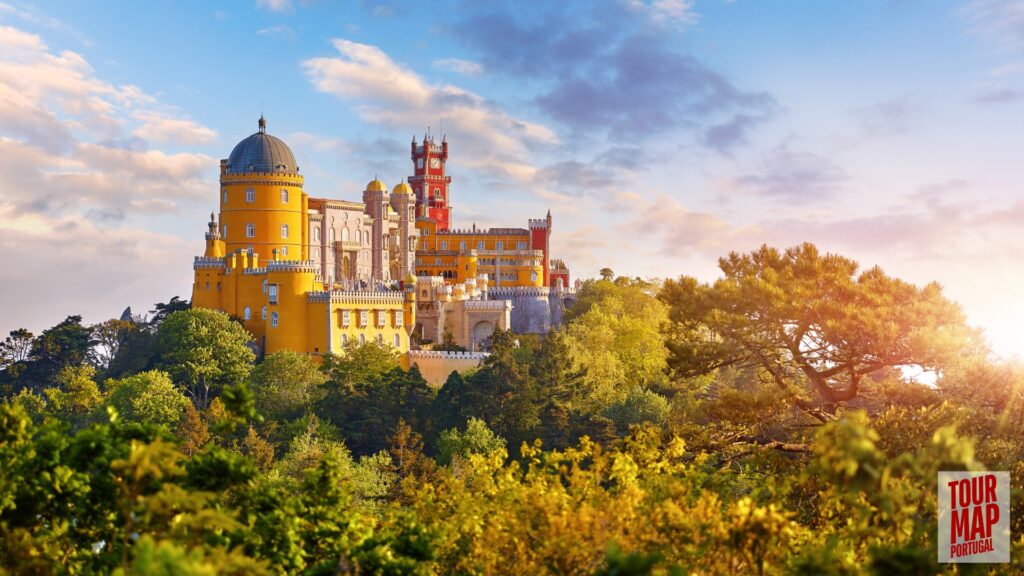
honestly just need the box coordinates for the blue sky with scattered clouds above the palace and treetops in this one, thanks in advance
[0,0,1024,357]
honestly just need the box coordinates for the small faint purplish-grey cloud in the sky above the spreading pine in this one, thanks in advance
[731,143,848,200]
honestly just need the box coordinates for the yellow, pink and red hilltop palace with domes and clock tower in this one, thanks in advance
[193,117,574,383]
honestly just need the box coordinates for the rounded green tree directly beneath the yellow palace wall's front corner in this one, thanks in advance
[249,351,327,419]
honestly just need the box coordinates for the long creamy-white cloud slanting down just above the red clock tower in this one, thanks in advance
[302,39,558,180]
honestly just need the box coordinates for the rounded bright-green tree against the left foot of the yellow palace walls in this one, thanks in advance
[157,308,256,409]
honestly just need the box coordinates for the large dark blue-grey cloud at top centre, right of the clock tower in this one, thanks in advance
[454,0,778,154]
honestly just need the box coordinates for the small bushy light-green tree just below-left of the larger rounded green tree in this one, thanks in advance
[106,370,190,428]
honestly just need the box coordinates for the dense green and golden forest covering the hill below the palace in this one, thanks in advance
[0,244,1024,575]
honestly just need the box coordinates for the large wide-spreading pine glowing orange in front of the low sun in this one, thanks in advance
[659,244,978,421]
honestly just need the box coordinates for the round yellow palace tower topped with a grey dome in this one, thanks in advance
[220,116,309,260]
